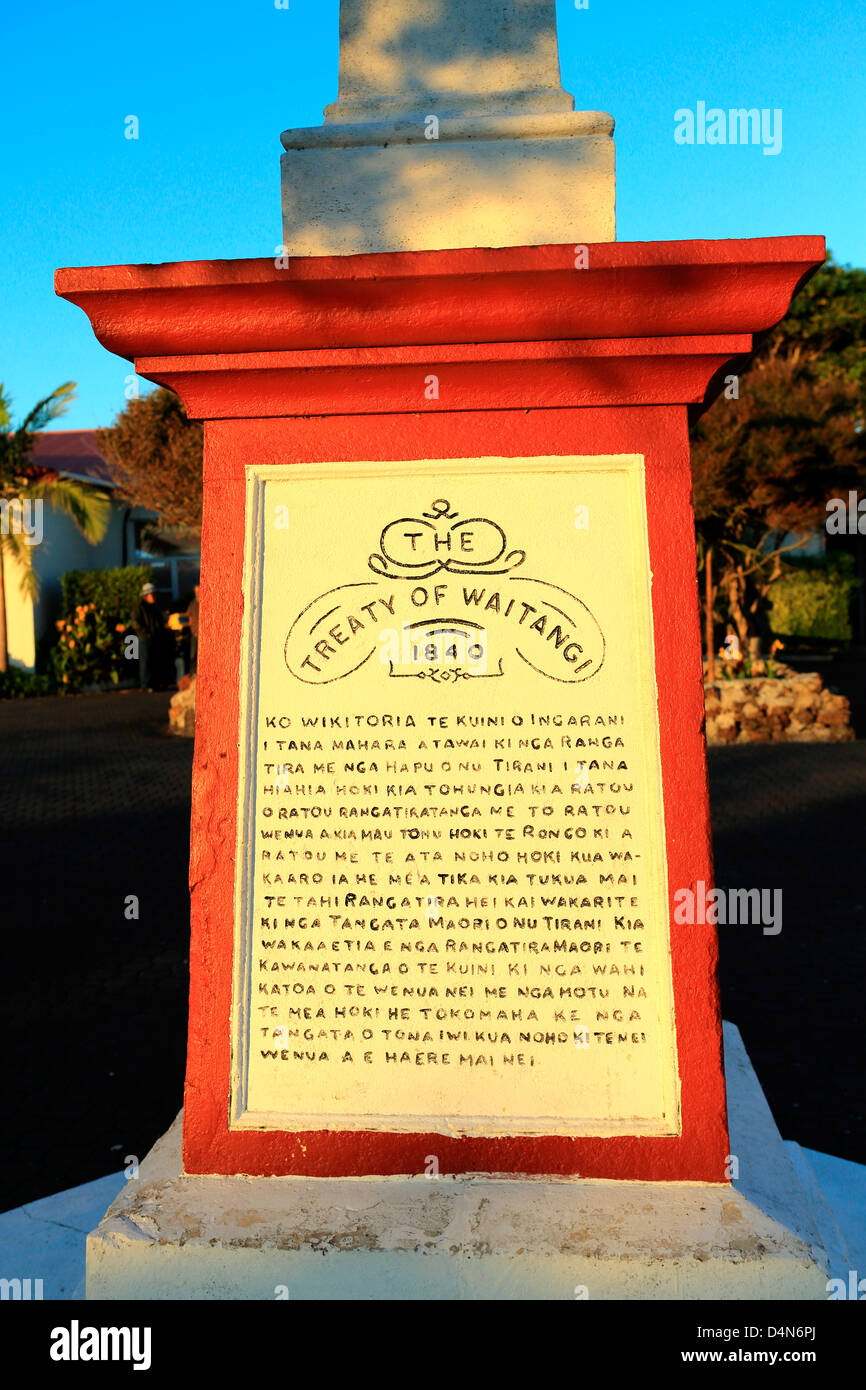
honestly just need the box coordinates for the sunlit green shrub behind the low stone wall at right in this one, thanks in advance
[770,553,859,642]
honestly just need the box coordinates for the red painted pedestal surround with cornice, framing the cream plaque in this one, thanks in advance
[58,238,823,1183]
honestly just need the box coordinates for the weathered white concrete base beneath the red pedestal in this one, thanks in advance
[88,1027,828,1300]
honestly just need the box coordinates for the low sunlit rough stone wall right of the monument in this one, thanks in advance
[703,667,855,744]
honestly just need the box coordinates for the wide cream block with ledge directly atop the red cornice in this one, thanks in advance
[281,107,616,256]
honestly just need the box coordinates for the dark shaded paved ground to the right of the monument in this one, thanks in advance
[710,741,866,1163]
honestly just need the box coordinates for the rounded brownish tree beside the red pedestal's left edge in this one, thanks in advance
[96,397,204,537]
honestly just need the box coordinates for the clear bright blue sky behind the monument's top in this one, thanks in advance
[0,0,866,428]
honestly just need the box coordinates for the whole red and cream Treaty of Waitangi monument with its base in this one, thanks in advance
[57,0,827,1298]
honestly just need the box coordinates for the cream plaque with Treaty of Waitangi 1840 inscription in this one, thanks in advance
[231,456,680,1136]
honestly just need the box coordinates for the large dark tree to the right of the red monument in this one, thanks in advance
[692,260,866,675]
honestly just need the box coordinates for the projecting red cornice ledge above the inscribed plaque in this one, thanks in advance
[56,236,824,418]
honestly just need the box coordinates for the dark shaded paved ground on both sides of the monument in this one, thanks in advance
[0,692,866,1211]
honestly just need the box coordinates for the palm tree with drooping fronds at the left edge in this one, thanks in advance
[0,381,111,671]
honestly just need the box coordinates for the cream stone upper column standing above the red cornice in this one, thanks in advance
[282,0,614,256]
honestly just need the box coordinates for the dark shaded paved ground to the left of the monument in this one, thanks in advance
[0,692,192,1209]
